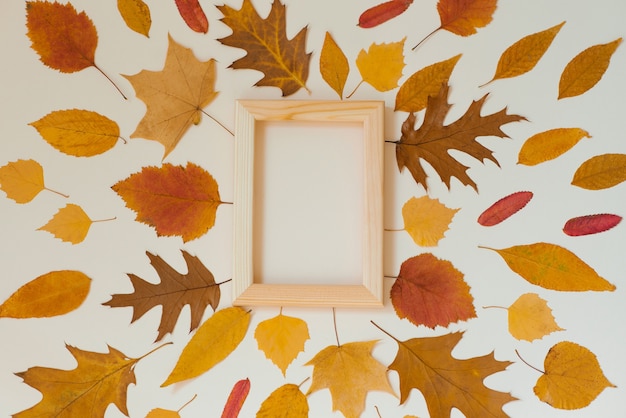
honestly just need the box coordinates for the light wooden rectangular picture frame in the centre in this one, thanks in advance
[232,100,384,308]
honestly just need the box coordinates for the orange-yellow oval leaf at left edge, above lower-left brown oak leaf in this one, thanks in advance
[0,270,91,318]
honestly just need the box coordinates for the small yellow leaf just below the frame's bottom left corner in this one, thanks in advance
[254,313,309,376]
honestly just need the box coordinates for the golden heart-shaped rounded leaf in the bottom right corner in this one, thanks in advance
[534,341,615,410]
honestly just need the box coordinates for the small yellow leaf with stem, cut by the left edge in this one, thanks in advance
[0,160,68,203]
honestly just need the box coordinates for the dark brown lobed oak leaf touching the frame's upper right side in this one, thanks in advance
[395,84,526,190]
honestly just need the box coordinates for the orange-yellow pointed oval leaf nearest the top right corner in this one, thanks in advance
[559,38,622,99]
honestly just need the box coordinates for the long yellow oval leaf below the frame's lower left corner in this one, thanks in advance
[161,307,250,387]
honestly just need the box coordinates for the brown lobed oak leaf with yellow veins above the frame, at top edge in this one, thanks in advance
[217,0,311,97]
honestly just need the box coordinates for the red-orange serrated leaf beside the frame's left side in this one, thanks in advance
[111,162,224,242]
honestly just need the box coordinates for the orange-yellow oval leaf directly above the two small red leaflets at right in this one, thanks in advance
[517,128,591,165]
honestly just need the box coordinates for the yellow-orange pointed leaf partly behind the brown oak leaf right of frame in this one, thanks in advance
[394,54,461,112]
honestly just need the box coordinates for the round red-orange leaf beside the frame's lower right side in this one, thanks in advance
[391,253,476,328]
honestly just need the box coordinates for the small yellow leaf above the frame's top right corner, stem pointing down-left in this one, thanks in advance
[356,38,406,91]
